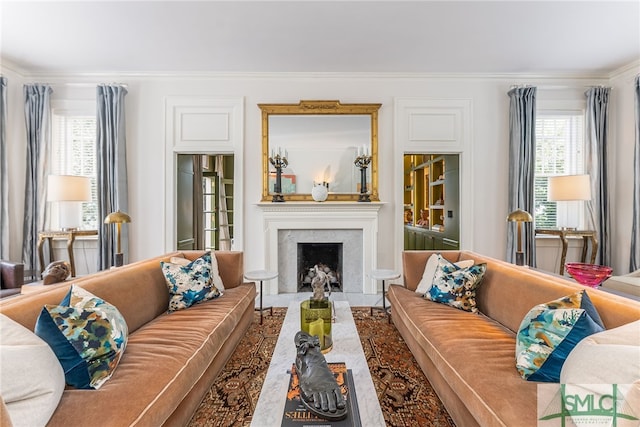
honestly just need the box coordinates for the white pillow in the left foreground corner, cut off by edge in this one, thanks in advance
[0,314,65,427]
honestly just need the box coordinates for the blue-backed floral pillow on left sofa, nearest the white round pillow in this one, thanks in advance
[35,286,129,389]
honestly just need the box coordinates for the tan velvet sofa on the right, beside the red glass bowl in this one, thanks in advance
[388,251,640,427]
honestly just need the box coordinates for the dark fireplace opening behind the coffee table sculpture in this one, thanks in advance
[297,243,342,292]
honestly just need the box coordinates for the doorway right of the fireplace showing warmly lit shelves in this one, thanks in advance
[403,154,460,250]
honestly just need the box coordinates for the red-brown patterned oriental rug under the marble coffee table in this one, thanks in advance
[189,307,455,427]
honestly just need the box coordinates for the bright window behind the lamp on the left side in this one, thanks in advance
[50,109,98,230]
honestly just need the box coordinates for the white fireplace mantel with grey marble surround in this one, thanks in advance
[258,202,383,295]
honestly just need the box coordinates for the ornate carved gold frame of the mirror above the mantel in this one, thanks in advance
[258,100,382,202]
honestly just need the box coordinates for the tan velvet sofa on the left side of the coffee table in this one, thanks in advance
[0,251,256,427]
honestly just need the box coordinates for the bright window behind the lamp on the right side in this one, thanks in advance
[534,111,584,228]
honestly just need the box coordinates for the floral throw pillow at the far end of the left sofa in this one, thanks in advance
[160,252,220,313]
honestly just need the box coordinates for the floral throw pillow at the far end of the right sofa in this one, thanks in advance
[424,254,487,313]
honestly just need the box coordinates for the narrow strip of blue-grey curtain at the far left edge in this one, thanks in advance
[0,77,10,259]
